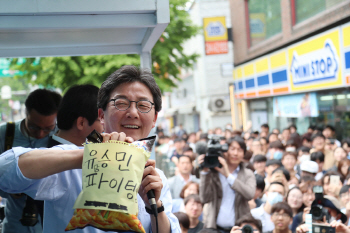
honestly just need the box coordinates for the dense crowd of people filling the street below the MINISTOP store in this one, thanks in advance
[156,124,350,233]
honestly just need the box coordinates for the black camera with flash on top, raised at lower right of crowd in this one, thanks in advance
[310,186,331,222]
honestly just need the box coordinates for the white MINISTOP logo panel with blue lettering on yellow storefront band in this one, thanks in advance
[290,40,339,85]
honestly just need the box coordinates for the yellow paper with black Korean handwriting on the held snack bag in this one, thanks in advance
[74,141,150,215]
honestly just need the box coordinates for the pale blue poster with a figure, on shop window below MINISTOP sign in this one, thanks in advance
[273,93,318,117]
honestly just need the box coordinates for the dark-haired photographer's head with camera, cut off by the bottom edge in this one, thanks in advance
[230,214,262,233]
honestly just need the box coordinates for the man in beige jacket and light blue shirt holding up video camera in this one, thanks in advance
[198,136,256,232]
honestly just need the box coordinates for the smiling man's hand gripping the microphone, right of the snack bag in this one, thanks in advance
[139,159,163,206]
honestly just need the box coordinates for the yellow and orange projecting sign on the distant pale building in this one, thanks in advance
[203,16,228,55]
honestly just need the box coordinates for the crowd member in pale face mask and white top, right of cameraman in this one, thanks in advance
[250,182,285,232]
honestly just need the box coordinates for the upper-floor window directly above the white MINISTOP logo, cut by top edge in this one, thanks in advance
[292,0,346,24]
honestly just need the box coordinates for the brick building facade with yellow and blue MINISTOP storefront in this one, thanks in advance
[230,0,350,139]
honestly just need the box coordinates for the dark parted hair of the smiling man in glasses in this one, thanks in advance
[97,66,162,112]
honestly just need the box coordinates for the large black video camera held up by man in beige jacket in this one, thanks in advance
[201,134,228,168]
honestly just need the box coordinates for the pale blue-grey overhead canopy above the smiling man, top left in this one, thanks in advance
[0,0,170,63]
